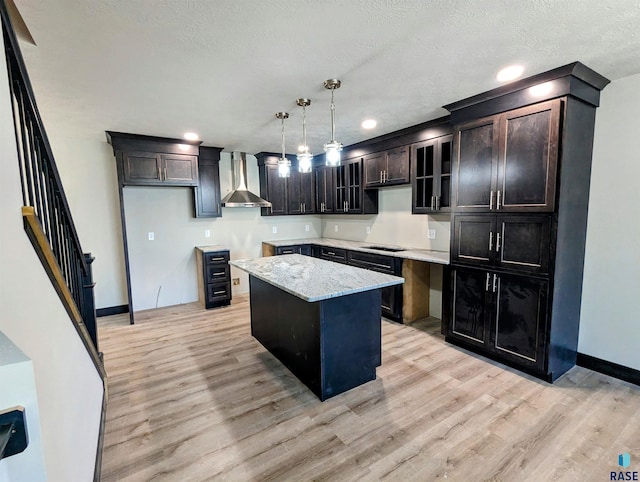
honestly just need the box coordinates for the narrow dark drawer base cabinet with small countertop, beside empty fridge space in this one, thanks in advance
[196,246,231,309]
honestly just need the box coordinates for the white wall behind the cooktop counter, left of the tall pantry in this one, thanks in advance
[322,186,451,318]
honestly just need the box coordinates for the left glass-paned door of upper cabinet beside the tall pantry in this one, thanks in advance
[411,139,438,214]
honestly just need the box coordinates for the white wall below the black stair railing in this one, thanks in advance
[0,34,103,481]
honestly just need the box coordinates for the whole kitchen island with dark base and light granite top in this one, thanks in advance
[231,254,404,401]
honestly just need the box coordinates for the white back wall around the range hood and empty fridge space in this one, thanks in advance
[124,152,321,311]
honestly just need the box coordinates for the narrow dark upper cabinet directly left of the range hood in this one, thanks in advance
[193,146,222,218]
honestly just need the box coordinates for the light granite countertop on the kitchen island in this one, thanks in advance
[231,254,404,302]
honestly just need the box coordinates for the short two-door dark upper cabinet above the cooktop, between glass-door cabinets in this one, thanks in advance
[363,146,411,188]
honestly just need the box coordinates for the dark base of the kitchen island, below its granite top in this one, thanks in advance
[249,275,382,401]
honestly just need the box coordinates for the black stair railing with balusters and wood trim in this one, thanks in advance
[0,2,103,380]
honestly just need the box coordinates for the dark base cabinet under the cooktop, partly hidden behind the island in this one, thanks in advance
[347,251,403,321]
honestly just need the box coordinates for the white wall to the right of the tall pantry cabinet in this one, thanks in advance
[578,74,640,370]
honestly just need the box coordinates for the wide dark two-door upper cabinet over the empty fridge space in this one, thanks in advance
[107,132,199,186]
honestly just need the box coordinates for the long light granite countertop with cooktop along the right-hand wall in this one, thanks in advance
[263,238,449,264]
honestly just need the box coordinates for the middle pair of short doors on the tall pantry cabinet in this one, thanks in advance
[451,214,552,274]
